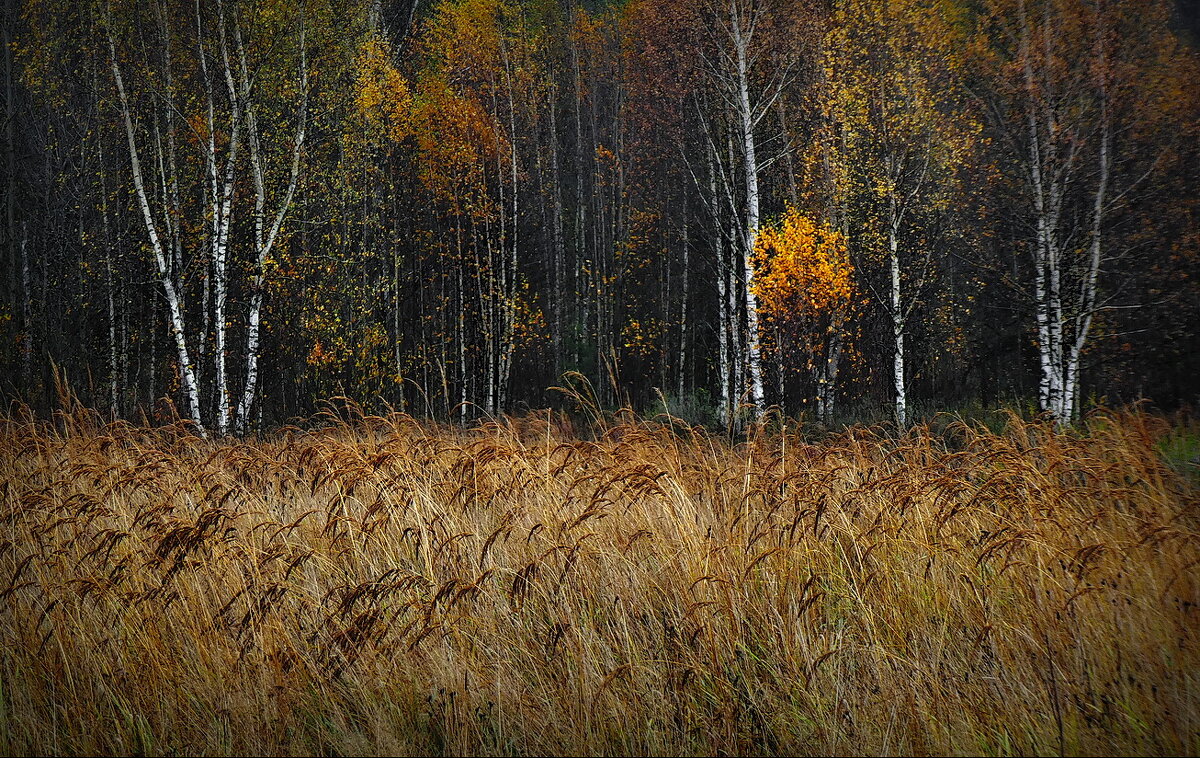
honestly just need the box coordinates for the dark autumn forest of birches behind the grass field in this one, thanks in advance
[0,0,1200,433]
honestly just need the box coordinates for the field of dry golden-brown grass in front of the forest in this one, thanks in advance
[0,402,1200,754]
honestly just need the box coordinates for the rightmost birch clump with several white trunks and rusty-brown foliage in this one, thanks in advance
[979,0,1172,423]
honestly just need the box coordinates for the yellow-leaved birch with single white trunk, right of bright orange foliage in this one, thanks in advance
[824,0,978,427]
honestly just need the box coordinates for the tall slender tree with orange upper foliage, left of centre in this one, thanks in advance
[416,0,529,419]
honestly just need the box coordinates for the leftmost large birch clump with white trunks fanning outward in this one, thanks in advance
[106,0,319,435]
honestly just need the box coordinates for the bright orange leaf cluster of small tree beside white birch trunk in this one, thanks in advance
[754,209,854,321]
